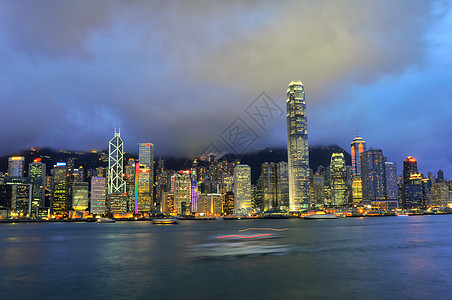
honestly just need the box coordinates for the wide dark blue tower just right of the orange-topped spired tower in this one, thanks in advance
[360,148,386,201]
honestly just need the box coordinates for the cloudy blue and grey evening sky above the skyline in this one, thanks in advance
[0,0,452,178]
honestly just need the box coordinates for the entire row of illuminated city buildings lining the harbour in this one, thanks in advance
[0,81,452,218]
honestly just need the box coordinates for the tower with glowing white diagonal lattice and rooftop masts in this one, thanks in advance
[108,128,126,194]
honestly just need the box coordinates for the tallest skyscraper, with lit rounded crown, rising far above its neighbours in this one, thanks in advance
[286,81,310,211]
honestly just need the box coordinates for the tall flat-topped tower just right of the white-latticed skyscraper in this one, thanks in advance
[138,143,154,212]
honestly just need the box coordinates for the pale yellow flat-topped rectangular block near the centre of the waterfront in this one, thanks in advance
[234,165,251,214]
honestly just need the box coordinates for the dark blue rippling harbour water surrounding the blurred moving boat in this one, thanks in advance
[0,215,452,299]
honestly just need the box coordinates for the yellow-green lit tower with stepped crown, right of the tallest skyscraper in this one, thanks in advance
[330,153,348,206]
